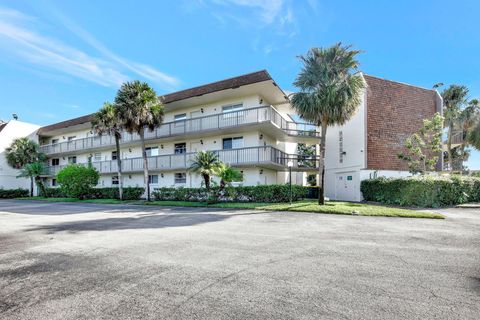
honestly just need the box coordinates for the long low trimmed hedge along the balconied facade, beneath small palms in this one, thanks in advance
[152,184,308,202]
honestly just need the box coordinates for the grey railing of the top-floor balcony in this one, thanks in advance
[40,106,320,154]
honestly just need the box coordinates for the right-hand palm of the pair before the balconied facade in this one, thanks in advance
[115,80,164,201]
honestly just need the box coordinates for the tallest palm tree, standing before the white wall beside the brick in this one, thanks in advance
[292,43,365,204]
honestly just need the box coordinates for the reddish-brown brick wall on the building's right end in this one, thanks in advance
[365,75,437,170]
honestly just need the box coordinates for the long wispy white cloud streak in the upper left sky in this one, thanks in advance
[0,8,179,89]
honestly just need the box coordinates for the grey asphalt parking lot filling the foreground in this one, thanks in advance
[0,200,480,319]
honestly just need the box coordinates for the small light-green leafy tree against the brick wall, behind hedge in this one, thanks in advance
[398,113,443,174]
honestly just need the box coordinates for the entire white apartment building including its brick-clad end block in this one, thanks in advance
[0,70,443,201]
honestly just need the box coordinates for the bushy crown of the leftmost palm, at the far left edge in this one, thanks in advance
[5,137,45,169]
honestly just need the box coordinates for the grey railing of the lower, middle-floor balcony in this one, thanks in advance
[48,146,319,176]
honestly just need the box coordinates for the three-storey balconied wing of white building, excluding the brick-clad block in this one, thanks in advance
[38,71,319,190]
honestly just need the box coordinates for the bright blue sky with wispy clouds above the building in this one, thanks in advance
[0,0,480,169]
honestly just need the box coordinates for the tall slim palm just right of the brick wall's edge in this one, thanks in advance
[441,84,468,171]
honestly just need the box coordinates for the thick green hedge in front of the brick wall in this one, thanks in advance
[360,176,480,208]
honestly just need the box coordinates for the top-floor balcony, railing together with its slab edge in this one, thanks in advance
[40,106,320,155]
